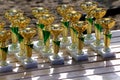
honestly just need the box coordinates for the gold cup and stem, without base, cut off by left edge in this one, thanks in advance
[0,30,11,66]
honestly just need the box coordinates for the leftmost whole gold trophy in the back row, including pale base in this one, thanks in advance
[5,9,23,53]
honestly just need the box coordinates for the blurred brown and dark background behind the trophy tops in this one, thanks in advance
[0,0,120,29]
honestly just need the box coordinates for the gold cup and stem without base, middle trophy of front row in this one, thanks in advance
[50,24,63,57]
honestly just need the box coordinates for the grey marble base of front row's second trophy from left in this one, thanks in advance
[22,60,38,69]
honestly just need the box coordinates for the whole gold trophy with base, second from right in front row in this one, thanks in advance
[69,21,88,61]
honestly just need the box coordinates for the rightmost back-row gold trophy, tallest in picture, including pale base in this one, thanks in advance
[80,2,97,45]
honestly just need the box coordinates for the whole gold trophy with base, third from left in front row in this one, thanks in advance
[49,24,64,64]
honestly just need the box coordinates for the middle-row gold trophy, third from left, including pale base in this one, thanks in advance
[66,10,81,53]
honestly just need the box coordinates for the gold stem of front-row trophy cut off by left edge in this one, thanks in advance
[0,42,7,66]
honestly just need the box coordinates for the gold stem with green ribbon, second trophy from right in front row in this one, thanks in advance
[78,33,84,54]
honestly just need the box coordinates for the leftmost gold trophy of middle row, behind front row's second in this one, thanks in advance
[14,17,30,60]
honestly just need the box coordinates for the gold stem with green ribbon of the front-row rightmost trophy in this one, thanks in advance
[104,29,112,51]
